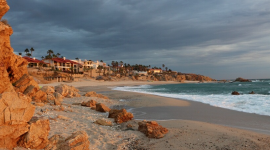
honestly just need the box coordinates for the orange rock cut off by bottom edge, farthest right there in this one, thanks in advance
[61,131,90,150]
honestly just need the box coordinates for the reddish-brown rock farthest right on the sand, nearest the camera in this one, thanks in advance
[138,121,168,139]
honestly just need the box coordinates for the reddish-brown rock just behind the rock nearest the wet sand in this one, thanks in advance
[108,109,133,123]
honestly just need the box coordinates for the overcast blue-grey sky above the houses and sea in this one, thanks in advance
[3,0,270,79]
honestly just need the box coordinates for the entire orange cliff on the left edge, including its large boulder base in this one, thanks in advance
[0,0,49,149]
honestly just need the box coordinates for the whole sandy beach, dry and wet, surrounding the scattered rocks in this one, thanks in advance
[35,81,270,150]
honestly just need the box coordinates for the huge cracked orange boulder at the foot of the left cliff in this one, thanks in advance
[0,92,35,149]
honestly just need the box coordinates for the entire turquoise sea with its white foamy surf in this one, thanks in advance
[114,79,270,116]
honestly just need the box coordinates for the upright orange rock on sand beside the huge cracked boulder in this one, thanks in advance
[18,118,50,149]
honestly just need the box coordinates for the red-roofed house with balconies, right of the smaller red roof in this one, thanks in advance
[43,57,83,72]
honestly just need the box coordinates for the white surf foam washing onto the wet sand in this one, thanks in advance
[113,86,270,116]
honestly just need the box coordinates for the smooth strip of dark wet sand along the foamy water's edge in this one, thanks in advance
[79,86,270,135]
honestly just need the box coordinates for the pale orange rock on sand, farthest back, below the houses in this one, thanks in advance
[54,84,81,98]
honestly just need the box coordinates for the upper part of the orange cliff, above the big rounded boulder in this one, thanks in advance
[0,0,46,101]
